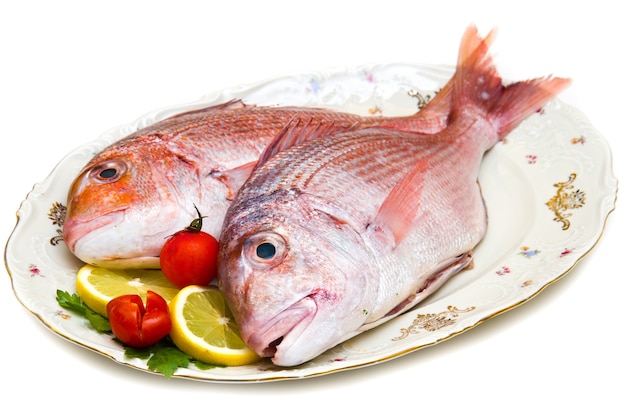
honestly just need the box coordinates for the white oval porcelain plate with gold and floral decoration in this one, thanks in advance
[5,64,617,382]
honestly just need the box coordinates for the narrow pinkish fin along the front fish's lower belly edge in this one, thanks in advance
[359,252,473,332]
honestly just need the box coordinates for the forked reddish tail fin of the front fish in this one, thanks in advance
[451,25,571,139]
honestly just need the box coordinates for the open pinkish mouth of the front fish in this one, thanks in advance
[247,296,317,358]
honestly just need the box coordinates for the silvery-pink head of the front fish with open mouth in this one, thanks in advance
[218,190,371,366]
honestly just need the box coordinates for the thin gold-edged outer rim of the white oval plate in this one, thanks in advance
[4,63,618,383]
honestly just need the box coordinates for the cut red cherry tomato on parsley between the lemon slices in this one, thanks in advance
[107,291,172,349]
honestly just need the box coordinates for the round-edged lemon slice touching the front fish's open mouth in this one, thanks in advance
[170,285,259,366]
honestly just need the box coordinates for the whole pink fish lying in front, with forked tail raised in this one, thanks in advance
[218,26,569,366]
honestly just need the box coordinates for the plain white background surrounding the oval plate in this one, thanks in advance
[0,0,626,416]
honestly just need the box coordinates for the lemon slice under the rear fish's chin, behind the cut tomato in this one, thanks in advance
[76,265,178,317]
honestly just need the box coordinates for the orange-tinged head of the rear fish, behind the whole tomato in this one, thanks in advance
[63,136,202,268]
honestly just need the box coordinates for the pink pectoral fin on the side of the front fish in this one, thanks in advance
[374,158,428,245]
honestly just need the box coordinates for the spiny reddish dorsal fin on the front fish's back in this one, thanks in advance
[257,117,358,167]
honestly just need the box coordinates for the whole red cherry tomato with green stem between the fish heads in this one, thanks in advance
[160,207,218,288]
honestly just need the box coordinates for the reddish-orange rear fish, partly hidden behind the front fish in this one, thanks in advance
[63,72,450,268]
